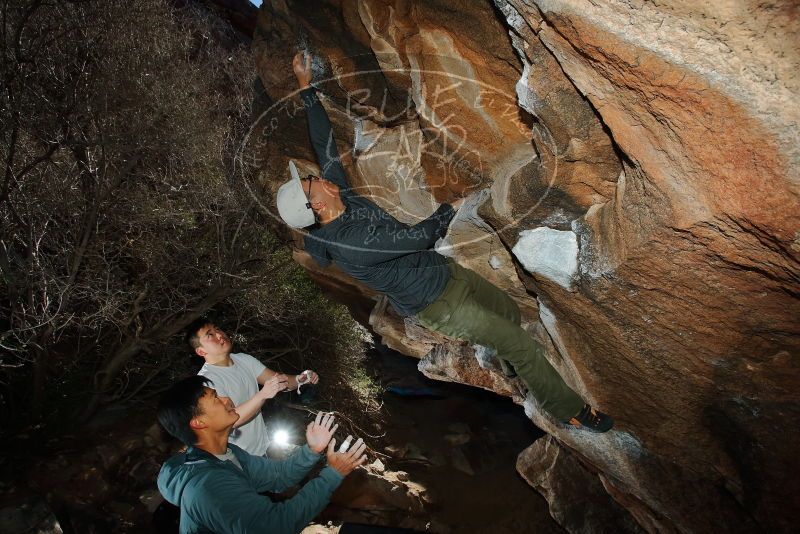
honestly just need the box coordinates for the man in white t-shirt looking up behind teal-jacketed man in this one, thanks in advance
[186,319,319,456]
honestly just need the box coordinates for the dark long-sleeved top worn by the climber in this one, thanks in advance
[300,88,455,315]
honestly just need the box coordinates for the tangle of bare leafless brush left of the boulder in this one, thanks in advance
[0,0,378,432]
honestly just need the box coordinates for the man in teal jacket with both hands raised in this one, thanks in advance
[158,376,366,534]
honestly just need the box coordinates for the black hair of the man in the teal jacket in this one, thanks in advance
[158,375,211,445]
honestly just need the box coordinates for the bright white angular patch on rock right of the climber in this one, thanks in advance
[511,227,578,289]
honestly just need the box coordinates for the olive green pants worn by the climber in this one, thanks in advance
[417,262,584,421]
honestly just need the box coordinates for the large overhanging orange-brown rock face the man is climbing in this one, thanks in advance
[248,0,800,532]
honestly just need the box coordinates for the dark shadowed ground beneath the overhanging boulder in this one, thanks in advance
[356,352,563,534]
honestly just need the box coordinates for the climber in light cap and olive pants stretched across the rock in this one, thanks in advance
[277,52,613,432]
